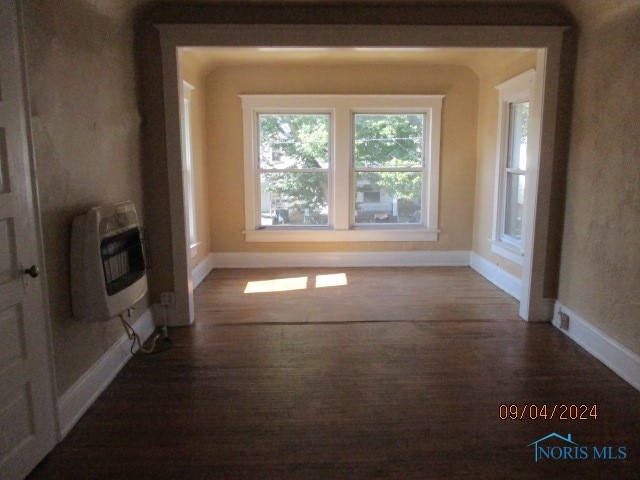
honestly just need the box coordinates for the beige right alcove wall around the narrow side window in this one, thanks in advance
[473,52,536,278]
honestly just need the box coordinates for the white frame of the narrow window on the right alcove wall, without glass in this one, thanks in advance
[490,69,535,265]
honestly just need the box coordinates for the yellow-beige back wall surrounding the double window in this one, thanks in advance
[207,64,478,252]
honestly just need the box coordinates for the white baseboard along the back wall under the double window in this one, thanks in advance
[211,251,469,268]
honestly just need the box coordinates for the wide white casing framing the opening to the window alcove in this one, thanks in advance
[155,23,569,325]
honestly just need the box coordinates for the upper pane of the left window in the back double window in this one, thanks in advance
[258,114,329,169]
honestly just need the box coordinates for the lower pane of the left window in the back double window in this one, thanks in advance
[260,172,329,225]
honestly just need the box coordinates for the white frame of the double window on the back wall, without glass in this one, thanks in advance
[240,95,444,242]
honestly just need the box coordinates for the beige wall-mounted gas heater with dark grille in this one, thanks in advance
[71,201,147,321]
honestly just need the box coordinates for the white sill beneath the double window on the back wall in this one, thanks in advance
[244,228,438,242]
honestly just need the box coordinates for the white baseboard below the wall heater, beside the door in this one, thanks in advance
[58,308,155,439]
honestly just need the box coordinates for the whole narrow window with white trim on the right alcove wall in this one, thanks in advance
[491,70,535,264]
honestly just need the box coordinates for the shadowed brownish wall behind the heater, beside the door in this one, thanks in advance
[24,0,146,394]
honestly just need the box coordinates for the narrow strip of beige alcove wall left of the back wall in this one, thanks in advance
[180,54,211,268]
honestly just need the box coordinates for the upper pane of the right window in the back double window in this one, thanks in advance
[354,114,425,168]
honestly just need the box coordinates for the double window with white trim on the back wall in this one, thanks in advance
[241,95,443,242]
